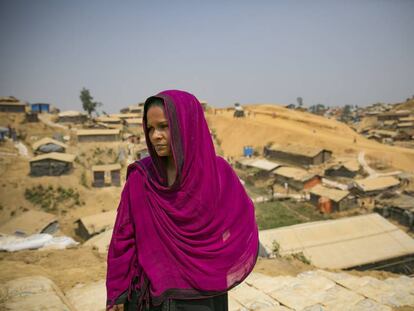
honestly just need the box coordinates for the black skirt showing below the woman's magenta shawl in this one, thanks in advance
[124,291,228,311]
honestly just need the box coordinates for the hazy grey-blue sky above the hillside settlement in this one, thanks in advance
[0,0,414,112]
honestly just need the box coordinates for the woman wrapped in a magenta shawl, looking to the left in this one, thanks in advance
[106,90,258,311]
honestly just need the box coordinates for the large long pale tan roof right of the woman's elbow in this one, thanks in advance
[259,214,414,269]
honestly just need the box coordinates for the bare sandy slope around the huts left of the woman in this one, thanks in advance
[0,114,126,239]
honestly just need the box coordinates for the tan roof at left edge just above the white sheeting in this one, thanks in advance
[0,210,57,235]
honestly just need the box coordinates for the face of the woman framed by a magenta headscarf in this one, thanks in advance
[147,106,171,157]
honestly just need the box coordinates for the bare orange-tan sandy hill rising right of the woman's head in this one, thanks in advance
[207,104,414,172]
